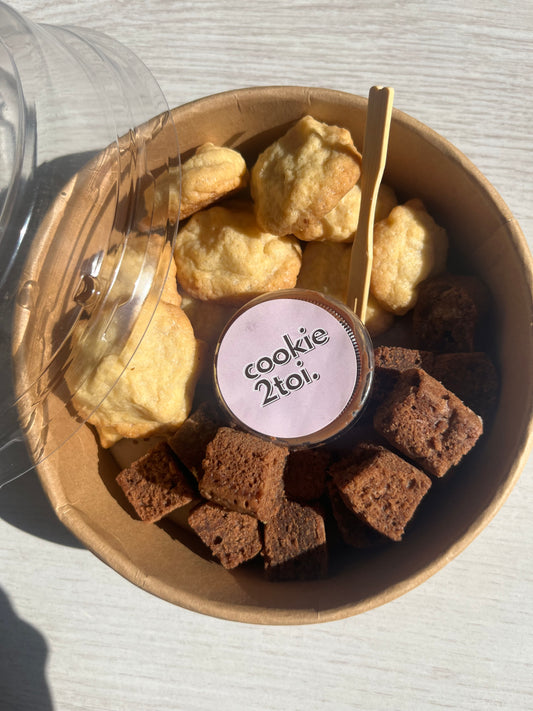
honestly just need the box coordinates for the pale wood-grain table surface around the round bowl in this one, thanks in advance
[0,0,533,711]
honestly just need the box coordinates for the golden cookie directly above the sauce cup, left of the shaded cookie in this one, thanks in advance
[174,206,302,305]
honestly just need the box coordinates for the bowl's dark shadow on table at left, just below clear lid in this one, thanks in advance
[0,471,83,552]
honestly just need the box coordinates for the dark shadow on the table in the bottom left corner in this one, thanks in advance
[0,588,53,711]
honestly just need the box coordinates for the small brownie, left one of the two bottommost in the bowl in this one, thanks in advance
[188,501,262,570]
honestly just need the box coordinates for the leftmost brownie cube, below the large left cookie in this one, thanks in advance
[116,442,196,522]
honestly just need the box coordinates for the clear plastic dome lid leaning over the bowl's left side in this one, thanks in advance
[0,3,179,486]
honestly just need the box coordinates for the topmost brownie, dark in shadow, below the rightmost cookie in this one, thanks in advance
[413,275,489,353]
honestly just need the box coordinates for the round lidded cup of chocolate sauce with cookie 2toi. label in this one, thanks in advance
[214,289,374,449]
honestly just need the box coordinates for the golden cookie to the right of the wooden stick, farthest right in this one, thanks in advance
[370,200,448,315]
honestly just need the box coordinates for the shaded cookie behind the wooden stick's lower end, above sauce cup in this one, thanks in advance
[297,242,394,337]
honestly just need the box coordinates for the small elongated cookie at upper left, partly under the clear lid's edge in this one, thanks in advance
[142,143,248,228]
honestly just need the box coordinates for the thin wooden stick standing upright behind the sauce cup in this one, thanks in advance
[347,86,394,323]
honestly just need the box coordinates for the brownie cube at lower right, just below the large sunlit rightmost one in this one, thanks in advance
[330,443,431,541]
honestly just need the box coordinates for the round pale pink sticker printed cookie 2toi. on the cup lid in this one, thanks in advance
[217,299,358,439]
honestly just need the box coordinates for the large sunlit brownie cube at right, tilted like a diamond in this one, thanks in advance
[374,368,483,477]
